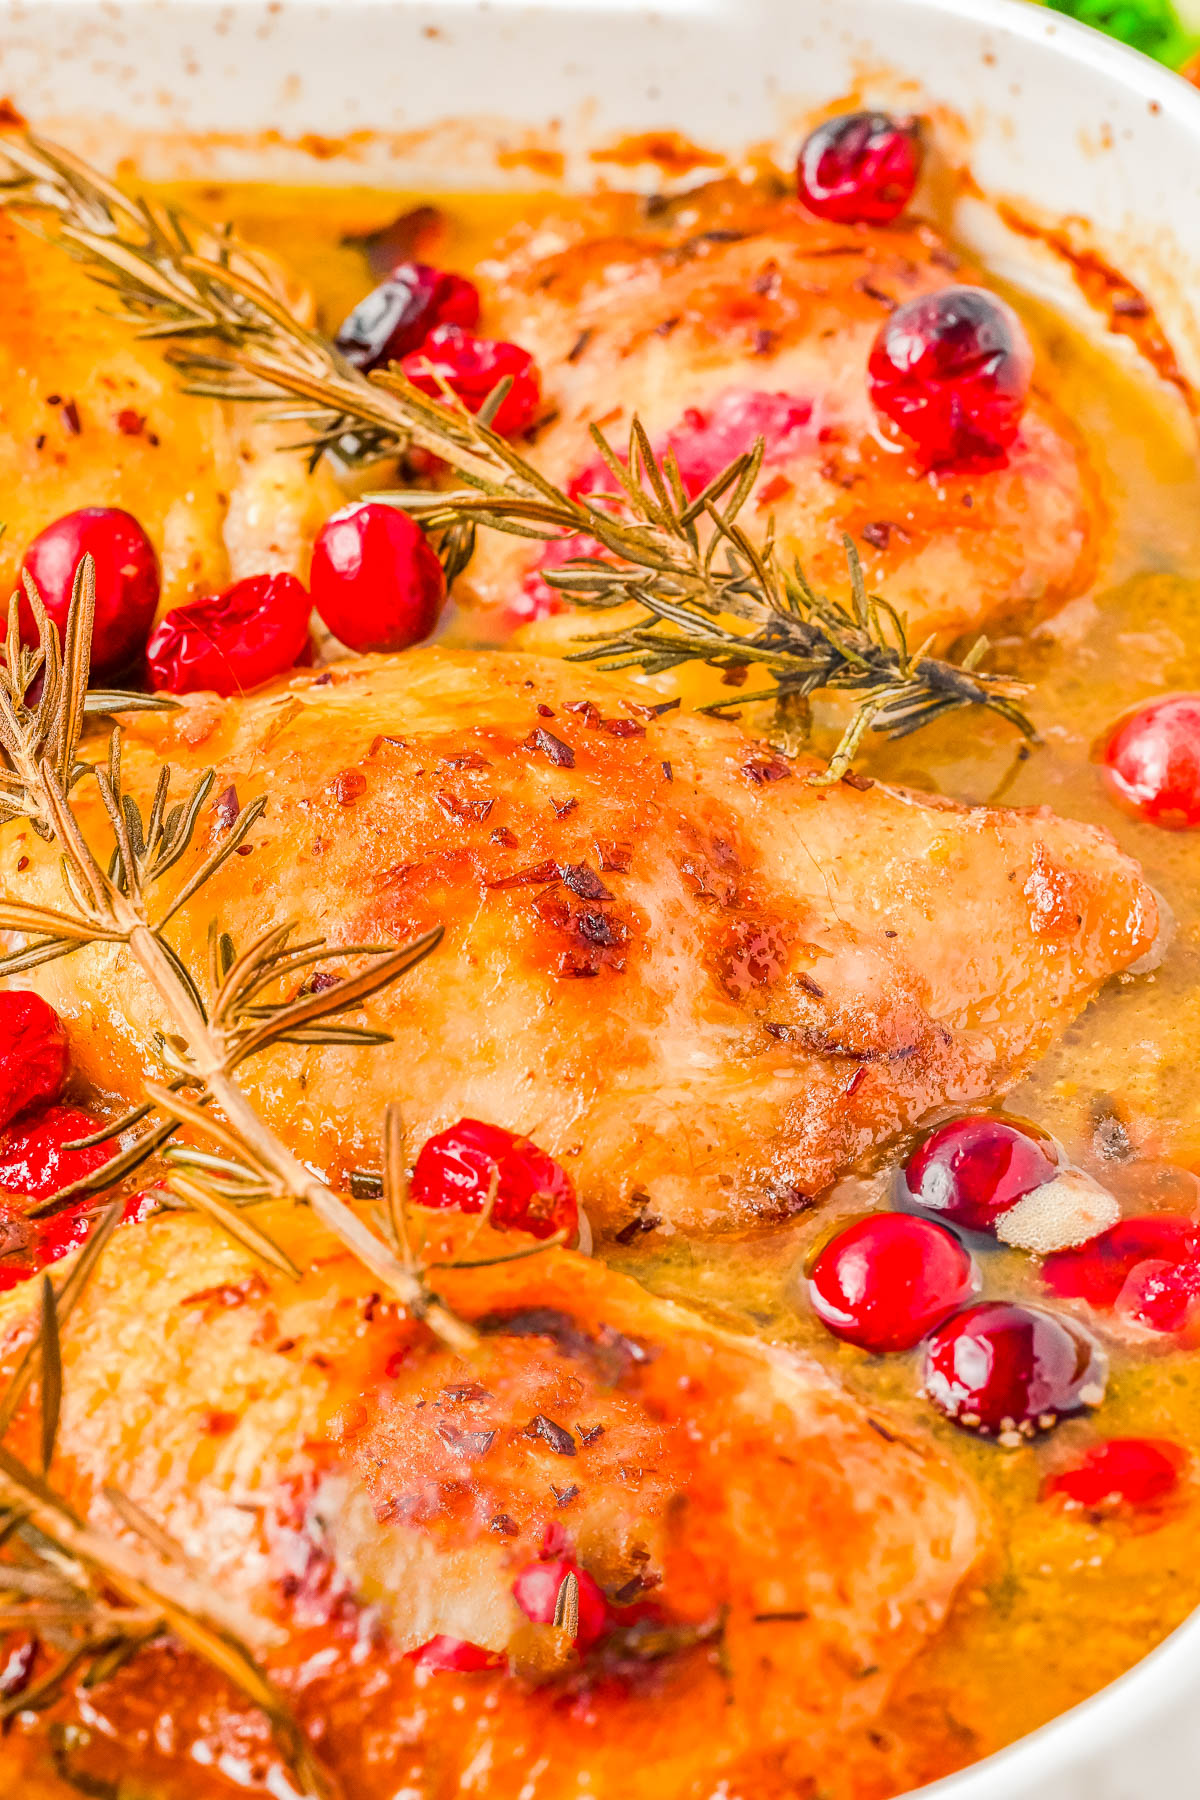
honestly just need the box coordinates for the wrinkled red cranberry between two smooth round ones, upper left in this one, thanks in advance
[146,574,313,695]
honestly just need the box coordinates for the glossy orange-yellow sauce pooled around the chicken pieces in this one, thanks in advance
[7,171,1200,1800]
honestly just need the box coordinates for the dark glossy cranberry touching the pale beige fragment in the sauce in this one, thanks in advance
[905,1112,1058,1231]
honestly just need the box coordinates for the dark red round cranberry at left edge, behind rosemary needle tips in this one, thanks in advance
[20,506,160,675]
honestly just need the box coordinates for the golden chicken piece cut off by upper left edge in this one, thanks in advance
[0,214,338,607]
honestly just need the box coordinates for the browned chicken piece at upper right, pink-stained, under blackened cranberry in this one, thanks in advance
[466,182,1103,641]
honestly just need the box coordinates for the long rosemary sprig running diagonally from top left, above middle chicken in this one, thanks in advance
[0,126,1033,779]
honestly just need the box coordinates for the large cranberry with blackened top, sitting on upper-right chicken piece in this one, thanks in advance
[867,288,1033,468]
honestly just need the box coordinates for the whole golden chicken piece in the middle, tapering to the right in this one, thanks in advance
[0,650,1157,1231]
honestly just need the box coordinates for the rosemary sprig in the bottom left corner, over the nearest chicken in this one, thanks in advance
[0,1202,338,1800]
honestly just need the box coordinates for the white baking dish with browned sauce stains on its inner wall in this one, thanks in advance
[0,0,1200,1800]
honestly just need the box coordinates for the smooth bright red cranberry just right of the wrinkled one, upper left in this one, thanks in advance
[309,500,446,652]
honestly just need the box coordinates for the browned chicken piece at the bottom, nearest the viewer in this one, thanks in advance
[0,1206,986,1800]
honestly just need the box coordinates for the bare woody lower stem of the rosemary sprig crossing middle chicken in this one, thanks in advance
[128,920,479,1355]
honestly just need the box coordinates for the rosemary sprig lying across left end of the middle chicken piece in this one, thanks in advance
[0,558,475,1350]
